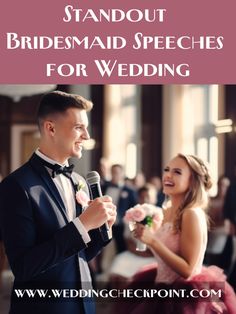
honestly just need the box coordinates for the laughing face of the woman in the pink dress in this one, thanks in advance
[162,157,191,196]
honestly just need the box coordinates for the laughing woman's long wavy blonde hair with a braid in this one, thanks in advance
[174,154,212,231]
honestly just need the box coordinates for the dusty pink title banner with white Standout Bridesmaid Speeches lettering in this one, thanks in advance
[0,0,233,84]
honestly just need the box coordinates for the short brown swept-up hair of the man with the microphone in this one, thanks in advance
[37,91,93,128]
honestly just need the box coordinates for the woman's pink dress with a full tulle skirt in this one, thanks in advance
[117,222,236,314]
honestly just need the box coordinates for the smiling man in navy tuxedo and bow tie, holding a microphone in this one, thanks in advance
[0,91,116,314]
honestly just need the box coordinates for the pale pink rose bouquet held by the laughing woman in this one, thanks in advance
[124,204,163,251]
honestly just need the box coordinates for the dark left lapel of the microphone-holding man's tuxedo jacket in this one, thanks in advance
[29,153,69,222]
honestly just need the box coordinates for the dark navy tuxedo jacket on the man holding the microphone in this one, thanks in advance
[0,154,106,314]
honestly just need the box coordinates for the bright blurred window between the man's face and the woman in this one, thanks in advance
[104,85,141,178]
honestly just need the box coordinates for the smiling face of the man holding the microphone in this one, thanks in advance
[50,108,90,161]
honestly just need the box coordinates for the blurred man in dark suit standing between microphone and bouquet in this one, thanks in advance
[103,164,137,253]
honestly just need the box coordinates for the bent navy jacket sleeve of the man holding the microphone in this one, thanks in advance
[0,178,89,280]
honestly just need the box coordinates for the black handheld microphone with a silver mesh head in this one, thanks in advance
[86,171,112,242]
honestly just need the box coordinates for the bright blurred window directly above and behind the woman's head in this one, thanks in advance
[184,85,219,194]
